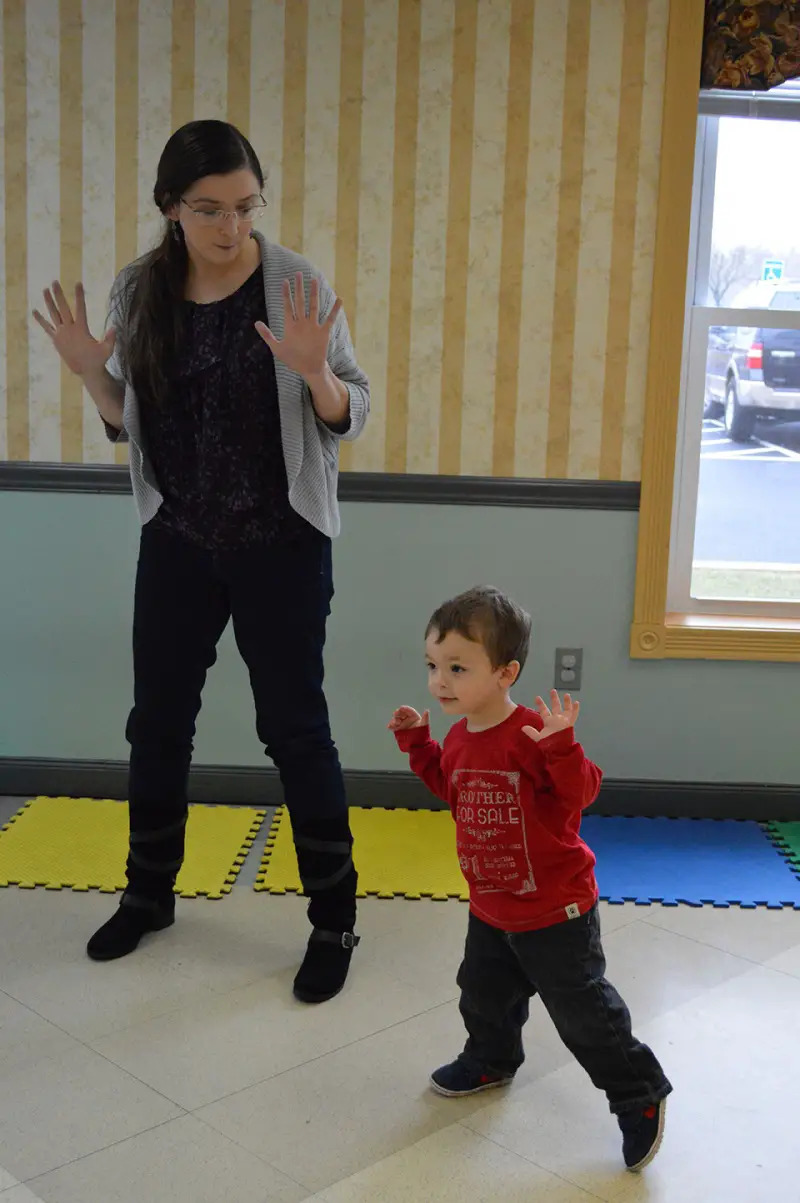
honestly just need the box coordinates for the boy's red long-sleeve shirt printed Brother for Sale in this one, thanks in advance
[397,706,603,931]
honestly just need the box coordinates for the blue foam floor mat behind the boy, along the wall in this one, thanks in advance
[581,814,800,909]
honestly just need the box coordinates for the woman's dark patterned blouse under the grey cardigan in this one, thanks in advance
[142,266,309,551]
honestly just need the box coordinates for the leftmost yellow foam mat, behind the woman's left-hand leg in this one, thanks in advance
[0,798,266,899]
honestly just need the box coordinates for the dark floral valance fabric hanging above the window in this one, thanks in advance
[700,0,800,91]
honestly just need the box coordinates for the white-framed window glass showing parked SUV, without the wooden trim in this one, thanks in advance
[666,98,800,617]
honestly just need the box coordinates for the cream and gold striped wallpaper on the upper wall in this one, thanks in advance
[0,0,669,480]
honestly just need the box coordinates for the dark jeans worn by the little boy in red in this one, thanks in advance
[458,907,672,1114]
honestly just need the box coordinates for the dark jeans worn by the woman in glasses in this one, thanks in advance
[126,522,357,931]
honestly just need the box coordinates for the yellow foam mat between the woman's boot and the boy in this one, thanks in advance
[254,806,468,901]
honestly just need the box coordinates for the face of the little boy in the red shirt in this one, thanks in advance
[425,630,520,717]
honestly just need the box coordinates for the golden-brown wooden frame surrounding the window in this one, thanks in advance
[630,0,800,662]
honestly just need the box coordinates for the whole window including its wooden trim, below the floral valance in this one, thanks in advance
[632,0,800,659]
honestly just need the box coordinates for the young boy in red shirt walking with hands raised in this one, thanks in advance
[389,588,672,1171]
